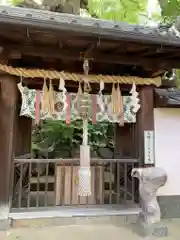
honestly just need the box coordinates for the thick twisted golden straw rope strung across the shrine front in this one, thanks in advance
[0,64,161,86]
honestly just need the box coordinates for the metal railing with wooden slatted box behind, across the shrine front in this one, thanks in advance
[12,159,138,208]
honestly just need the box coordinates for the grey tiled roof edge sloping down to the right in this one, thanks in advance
[0,6,180,46]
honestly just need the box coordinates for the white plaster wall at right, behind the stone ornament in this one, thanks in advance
[154,108,180,195]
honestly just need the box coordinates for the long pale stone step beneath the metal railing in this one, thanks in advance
[10,206,140,227]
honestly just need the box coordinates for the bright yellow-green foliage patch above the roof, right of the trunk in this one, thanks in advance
[88,0,147,23]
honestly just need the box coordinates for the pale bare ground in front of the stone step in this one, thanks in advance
[0,219,180,240]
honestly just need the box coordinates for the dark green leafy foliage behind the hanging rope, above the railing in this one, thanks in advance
[32,120,114,157]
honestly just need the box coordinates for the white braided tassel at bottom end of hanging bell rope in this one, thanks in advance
[78,167,91,197]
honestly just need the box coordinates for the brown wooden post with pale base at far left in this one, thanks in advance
[0,74,18,225]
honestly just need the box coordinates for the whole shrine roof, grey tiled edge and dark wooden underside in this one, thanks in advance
[0,6,180,88]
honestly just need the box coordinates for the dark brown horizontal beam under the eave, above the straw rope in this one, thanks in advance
[2,44,180,69]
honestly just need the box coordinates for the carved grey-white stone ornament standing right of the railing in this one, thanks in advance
[131,167,168,237]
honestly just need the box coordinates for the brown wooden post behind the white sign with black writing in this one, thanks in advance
[137,86,154,167]
